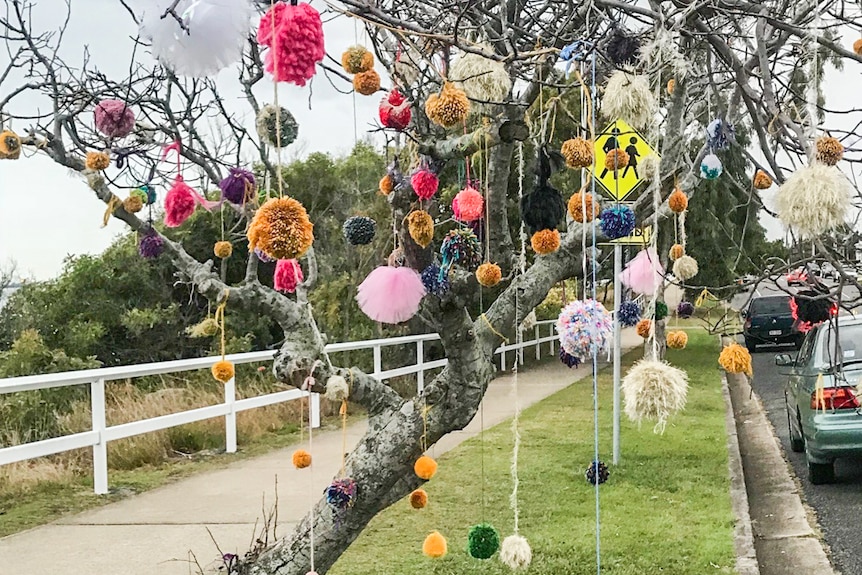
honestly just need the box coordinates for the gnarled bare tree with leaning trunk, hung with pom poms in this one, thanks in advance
[0,0,862,575]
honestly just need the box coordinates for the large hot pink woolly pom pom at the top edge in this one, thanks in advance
[257,2,326,86]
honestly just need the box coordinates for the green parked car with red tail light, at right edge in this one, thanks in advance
[775,316,862,485]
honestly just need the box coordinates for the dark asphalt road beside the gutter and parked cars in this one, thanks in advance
[740,344,862,575]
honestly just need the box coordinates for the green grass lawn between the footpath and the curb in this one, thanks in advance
[330,331,735,575]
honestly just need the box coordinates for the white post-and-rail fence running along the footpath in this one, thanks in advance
[0,320,557,494]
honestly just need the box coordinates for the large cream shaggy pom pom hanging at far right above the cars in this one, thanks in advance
[775,163,851,237]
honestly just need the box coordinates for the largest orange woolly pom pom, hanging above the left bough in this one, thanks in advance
[248,196,314,260]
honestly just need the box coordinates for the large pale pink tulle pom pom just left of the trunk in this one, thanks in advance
[356,266,425,323]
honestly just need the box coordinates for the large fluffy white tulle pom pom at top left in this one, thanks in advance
[141,0,253,78]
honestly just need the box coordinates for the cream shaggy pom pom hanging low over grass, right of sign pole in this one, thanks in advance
[622,359,688,433]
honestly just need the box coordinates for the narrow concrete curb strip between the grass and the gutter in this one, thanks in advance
[721,371,760,575]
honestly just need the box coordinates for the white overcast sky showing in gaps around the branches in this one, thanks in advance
[0,0,862,280]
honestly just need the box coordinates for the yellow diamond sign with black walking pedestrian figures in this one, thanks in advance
[591,119,659,202]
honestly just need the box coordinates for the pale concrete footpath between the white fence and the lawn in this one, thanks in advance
[0,330,642,575]
